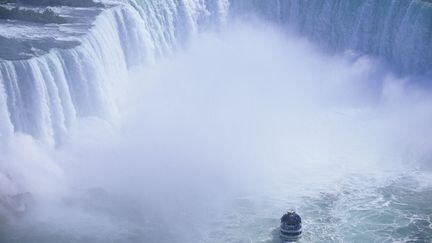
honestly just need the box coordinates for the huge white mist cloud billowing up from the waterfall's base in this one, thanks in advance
[0,22,432,242]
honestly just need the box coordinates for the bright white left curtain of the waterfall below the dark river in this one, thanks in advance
[0,1,227,145]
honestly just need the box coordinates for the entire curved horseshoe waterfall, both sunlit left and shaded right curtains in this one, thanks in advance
[0,0,432,144]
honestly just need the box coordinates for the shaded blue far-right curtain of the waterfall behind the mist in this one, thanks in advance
[230,0,432,76]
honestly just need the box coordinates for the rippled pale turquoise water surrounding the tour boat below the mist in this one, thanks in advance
[1,173,432,243]
